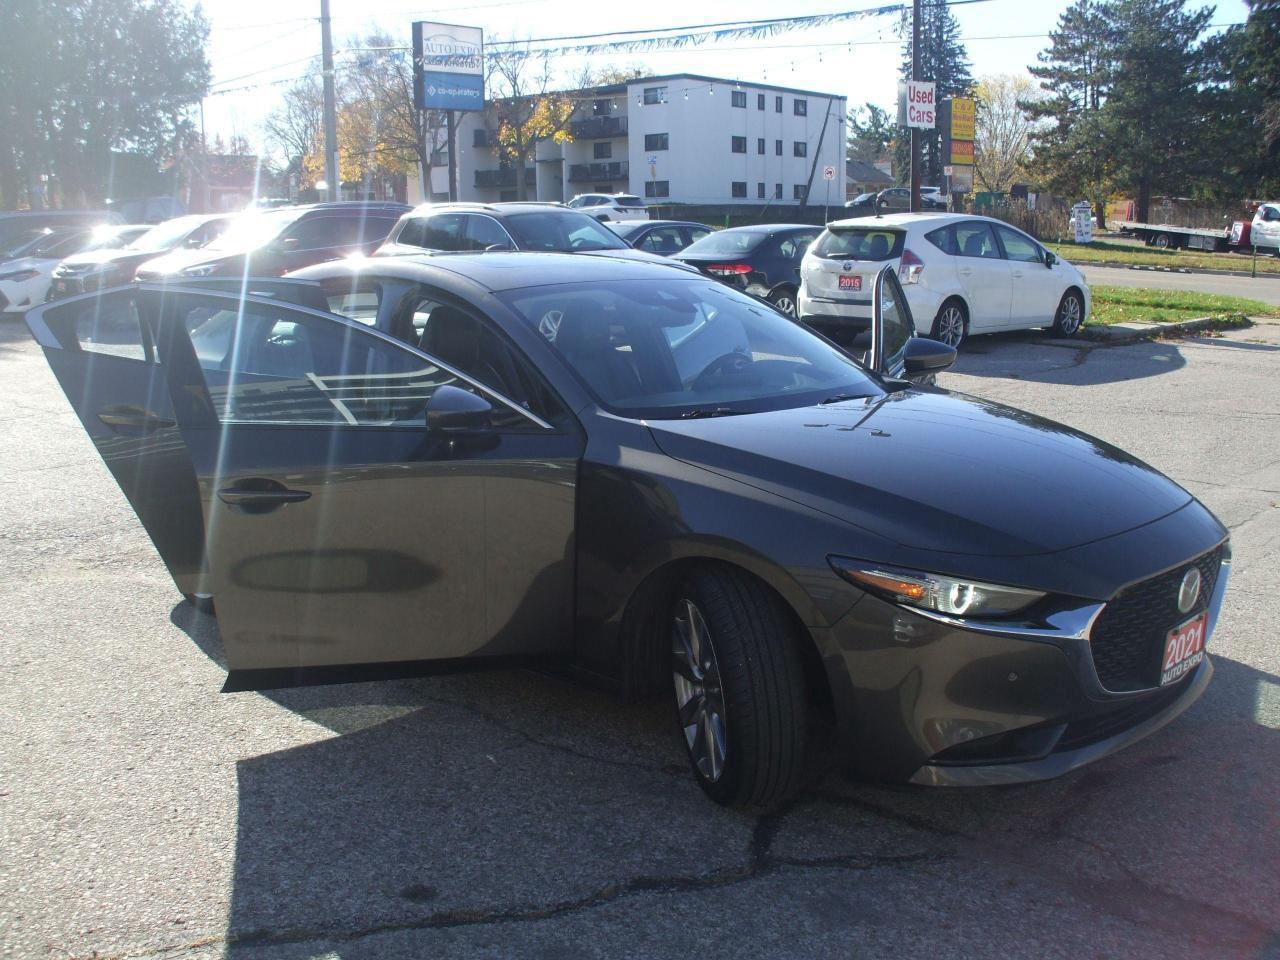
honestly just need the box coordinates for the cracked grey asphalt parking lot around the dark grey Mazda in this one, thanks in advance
[0,323,1280,960]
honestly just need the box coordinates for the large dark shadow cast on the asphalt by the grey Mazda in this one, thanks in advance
[173,604,1280,960]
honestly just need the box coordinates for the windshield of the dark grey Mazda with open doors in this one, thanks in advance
[500,278,882,420]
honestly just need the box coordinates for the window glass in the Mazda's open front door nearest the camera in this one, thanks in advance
[175,297,470,429]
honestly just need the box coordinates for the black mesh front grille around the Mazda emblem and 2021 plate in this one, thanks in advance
[1089,545,1226,691]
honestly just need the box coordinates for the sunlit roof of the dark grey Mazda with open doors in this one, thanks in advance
[289,251,714,291]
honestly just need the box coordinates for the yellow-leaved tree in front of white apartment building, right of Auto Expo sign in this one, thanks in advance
[485,45,589,200]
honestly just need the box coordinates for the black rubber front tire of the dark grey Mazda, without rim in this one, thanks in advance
[668,564,809,809]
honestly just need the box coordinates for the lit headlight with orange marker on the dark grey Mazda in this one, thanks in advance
[829,557,1044,617]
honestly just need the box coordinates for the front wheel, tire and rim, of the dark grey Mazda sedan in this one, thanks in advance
[671,567,808,808]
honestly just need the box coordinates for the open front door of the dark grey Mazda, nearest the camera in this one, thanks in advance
[148,284,582,690]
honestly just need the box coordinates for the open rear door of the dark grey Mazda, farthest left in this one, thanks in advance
[26,287,206,595]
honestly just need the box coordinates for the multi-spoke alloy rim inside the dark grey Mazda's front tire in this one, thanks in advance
[671,598,728,783]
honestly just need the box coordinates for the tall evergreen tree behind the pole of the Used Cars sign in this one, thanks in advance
[895,0,973,184]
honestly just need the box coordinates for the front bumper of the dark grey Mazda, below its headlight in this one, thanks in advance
[824,545,1230,786]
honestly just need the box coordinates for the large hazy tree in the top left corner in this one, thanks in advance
[0,0,210,206]
